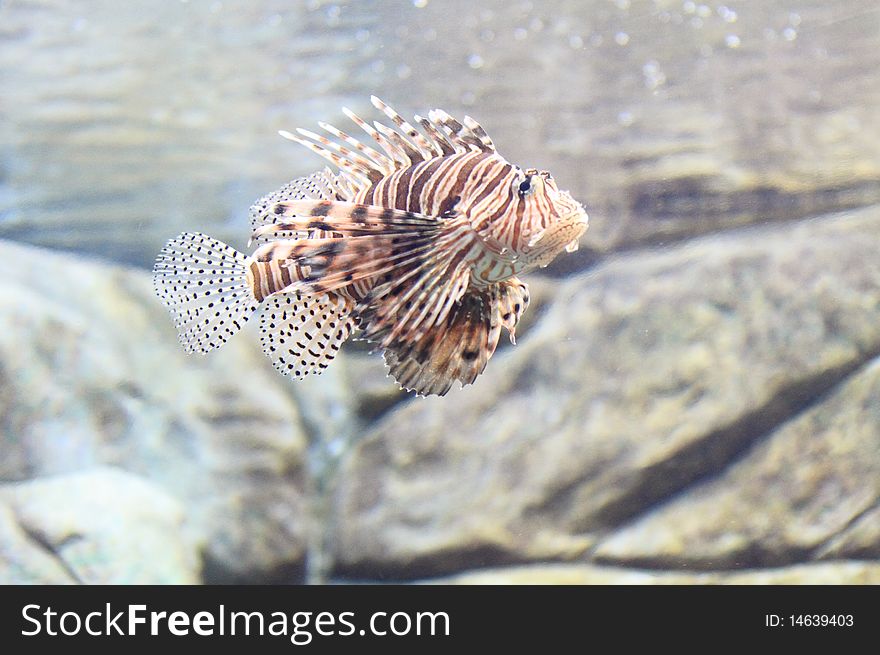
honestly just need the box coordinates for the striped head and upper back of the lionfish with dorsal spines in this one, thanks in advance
[276,97,587,284]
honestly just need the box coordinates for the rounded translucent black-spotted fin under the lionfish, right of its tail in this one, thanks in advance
[259,291,354,378]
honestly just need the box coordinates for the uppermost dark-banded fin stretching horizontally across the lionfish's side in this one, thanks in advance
[253,200,442,239]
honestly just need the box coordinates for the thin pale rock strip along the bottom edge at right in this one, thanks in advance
[434,562,880,585]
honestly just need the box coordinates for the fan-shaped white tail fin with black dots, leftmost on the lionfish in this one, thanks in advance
[153,232,259,353]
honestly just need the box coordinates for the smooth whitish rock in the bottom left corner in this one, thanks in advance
[0,468,199,584]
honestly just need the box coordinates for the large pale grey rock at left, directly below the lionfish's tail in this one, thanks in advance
[0,242,316,580]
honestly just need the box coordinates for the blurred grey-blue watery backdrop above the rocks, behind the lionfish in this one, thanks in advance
[0,0,880,268]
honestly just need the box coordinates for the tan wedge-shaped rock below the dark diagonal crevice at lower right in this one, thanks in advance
[593,359,880,569]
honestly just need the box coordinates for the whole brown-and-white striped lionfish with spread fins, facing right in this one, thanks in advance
[153,97,588,396]
